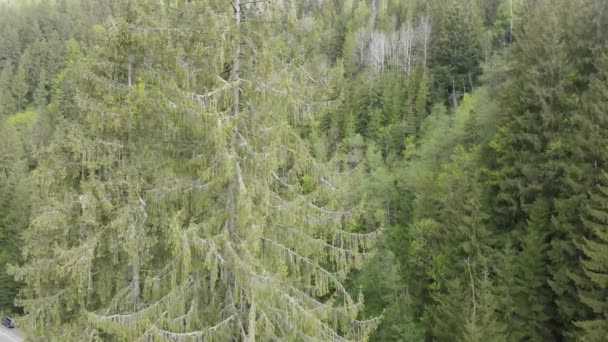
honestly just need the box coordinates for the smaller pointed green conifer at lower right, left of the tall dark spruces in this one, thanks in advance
[434,151,498,341]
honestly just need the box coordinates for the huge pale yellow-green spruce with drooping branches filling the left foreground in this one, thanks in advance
[14,0,377,341]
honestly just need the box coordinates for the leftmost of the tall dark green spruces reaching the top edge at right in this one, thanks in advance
[490,1,580,338]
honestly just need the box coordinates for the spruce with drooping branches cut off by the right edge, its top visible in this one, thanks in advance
[564,42,608,341]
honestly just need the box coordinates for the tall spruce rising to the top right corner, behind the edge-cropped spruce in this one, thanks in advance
[549,0,608,340]
